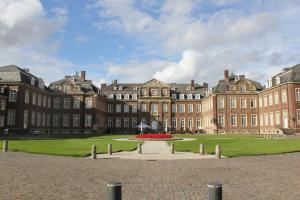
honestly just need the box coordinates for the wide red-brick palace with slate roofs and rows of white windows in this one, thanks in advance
[0,65,300,134]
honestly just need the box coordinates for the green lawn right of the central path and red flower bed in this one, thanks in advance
[175,134,300,157]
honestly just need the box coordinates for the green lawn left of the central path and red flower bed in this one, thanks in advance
[0,135,138,157]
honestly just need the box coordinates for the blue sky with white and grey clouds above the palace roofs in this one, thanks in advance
[0,0,300,85]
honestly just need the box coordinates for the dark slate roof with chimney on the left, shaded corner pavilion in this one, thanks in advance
[49,75,99,93]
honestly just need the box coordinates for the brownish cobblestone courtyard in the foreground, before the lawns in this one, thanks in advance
[0,152,300,200]
